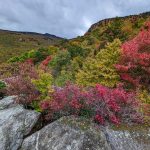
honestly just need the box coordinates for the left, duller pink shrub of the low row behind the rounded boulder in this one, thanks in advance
[41,84,86,117]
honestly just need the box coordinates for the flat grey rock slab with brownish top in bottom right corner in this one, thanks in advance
[105,126,150,150]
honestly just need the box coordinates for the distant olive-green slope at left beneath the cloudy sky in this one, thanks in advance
[0,30,62,63]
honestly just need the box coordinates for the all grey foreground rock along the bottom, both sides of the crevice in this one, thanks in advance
[0,97,150,150]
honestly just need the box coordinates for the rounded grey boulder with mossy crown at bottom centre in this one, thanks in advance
[20,117,111,150]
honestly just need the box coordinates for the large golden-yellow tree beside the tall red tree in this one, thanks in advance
[76,39,121,87]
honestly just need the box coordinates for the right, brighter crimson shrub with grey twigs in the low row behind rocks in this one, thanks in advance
[87,84,142,124]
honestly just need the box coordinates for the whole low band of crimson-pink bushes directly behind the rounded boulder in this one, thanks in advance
[41,84,142,125]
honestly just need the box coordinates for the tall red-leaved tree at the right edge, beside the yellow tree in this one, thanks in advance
[116,22,150,88]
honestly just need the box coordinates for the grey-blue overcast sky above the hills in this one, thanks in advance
[0,0,150,38]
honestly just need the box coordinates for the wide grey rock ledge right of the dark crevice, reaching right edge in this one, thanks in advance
[20,116,150,150]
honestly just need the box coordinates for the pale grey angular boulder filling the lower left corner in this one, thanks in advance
[0,97,40,150]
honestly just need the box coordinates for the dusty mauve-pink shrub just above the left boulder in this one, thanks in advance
[5,63,39,106]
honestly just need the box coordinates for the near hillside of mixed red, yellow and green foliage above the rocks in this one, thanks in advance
[0,12,150,125]
